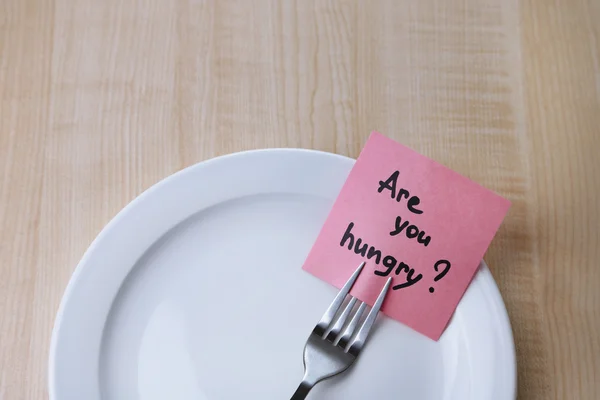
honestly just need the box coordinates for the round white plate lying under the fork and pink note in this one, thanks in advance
[49,149,516,400]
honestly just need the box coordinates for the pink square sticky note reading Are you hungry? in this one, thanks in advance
[303,132,510,340]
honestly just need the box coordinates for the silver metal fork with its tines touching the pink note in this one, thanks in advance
[290,262,392,400]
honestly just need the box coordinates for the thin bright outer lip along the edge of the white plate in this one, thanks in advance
[47,147,518,400]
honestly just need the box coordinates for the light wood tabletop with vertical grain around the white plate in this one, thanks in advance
[0,0,600,400]
